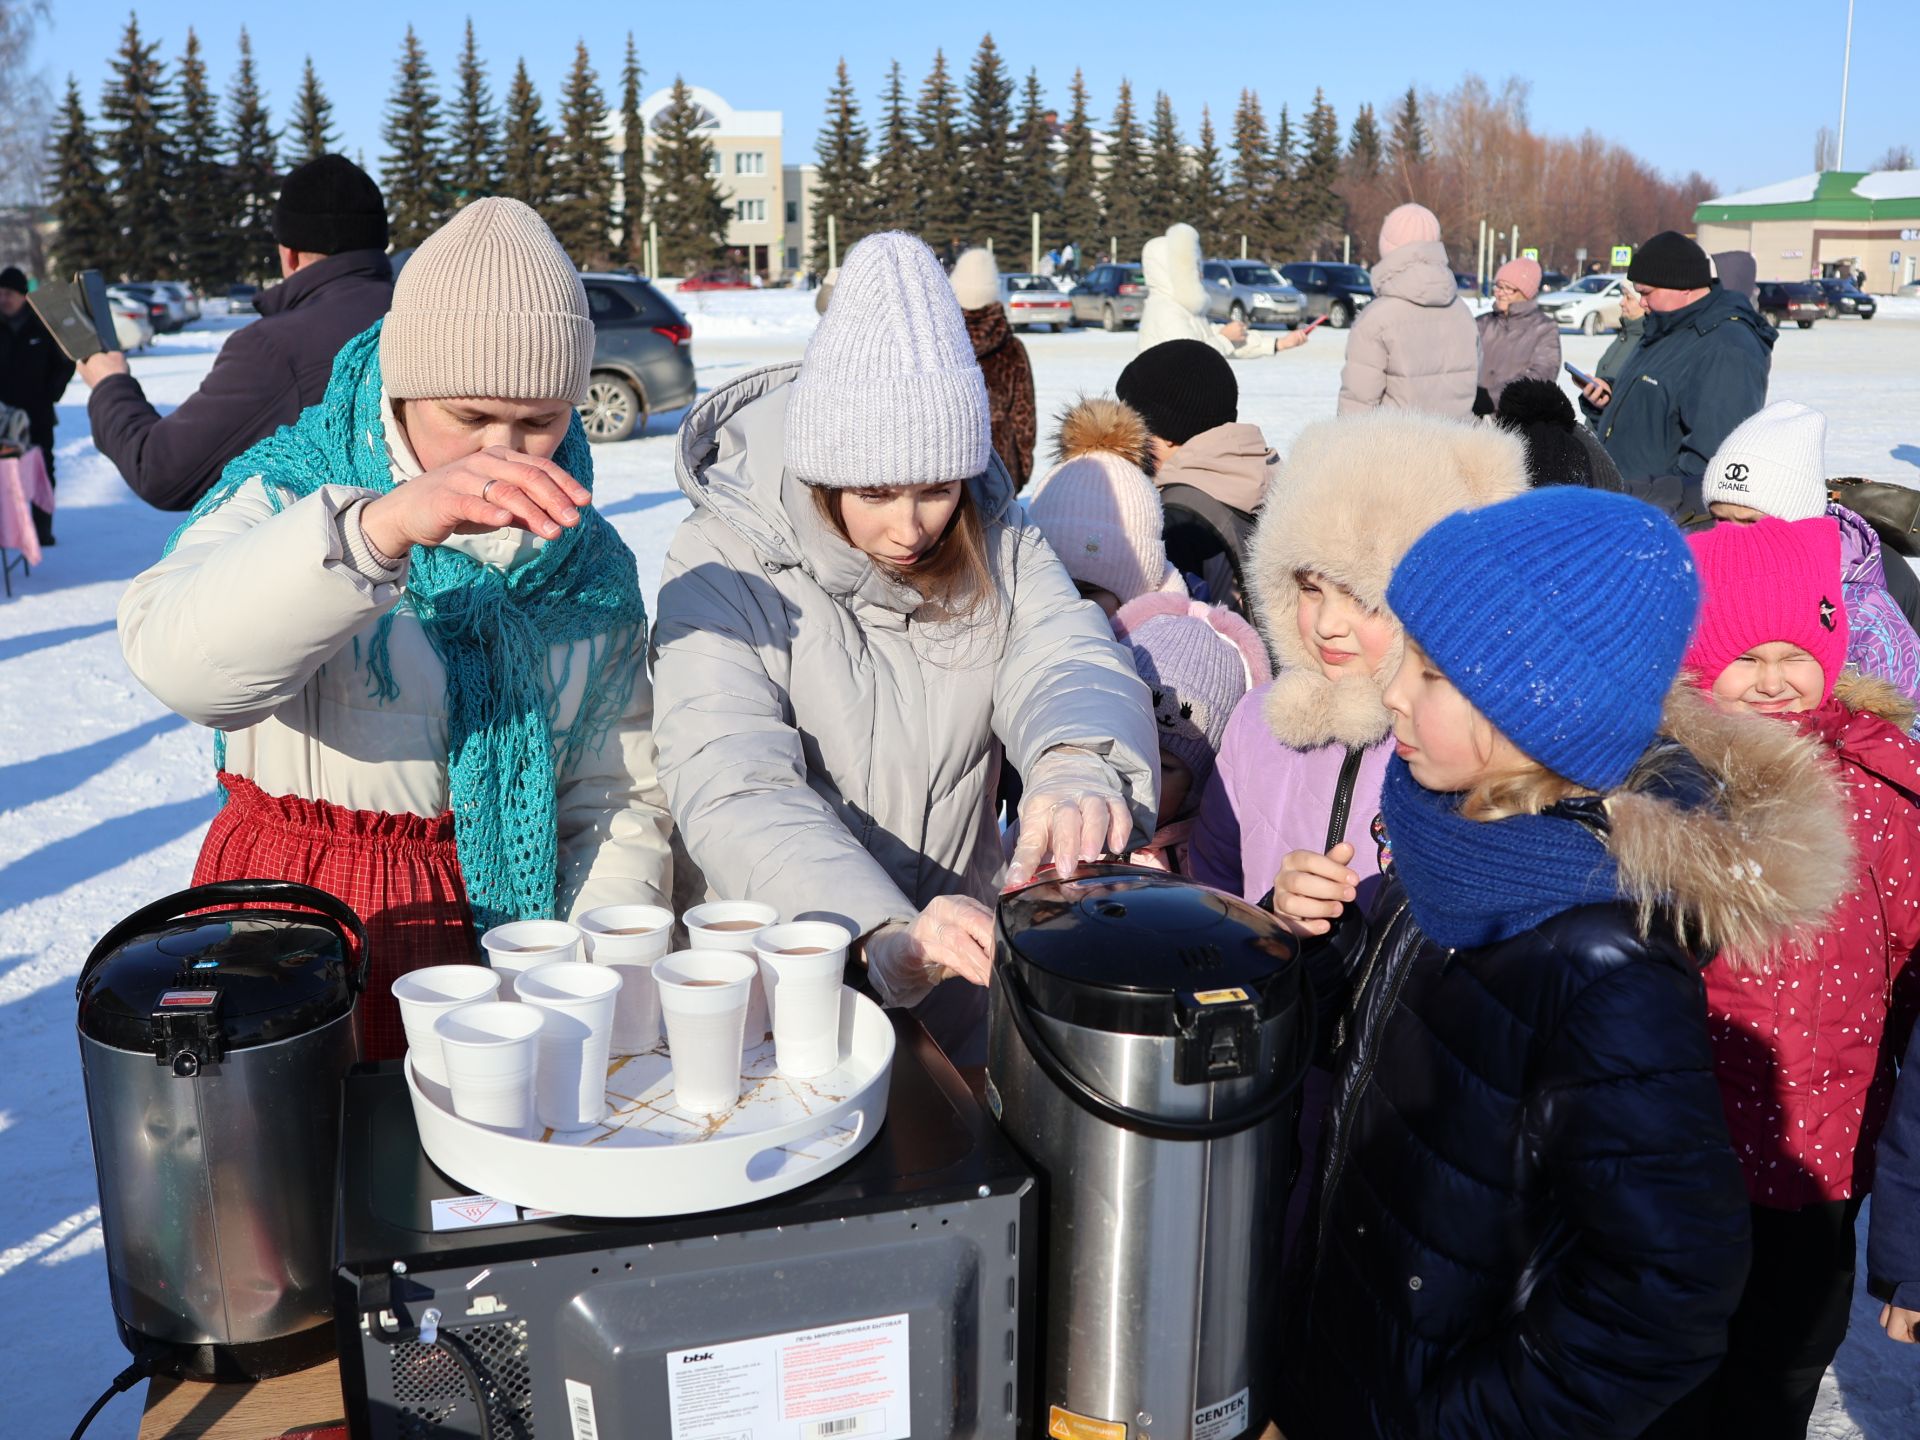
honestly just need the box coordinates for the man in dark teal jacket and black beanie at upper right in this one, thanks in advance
[1584,230,1774,488]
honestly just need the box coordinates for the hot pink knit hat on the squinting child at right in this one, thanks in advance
[1686,515,1847,699]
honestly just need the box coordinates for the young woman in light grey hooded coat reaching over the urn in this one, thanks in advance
[653,234,1160,1064]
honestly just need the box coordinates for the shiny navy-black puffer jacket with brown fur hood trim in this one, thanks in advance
[1281,701,1851,1440]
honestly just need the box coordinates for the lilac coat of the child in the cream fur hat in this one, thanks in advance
[1187,684,1394,906]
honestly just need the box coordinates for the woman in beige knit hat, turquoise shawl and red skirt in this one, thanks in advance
[119,200,672,1058]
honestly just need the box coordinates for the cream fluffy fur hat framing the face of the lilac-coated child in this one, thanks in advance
[1246,411,1526,749]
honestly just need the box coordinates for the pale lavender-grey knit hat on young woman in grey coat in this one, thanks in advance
[787,232,993,490]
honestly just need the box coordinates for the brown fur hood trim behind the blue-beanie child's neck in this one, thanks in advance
[1607,678,1855,972]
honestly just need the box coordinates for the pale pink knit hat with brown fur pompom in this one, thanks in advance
[1027,397,1187,605]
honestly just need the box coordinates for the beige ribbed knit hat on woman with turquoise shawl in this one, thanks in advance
[380,196,593,405]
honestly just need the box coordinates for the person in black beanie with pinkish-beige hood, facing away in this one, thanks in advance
[1114,340,1279,628]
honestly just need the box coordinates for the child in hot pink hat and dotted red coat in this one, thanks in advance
[1661,515,1920,1436]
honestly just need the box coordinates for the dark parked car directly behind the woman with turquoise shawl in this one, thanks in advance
[580,273,699,444]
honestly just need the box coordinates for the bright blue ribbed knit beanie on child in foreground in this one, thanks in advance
[1386,486,1699,791]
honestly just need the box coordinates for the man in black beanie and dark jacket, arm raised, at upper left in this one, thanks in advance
[81,156,394,511]
